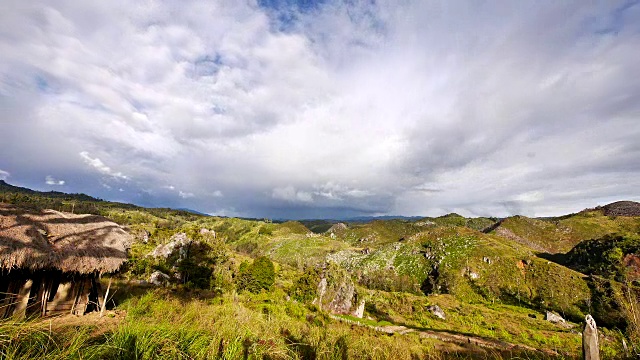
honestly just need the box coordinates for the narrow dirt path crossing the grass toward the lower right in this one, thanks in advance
[331,315,559,356]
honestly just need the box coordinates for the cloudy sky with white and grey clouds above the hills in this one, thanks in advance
[0,0,640,218]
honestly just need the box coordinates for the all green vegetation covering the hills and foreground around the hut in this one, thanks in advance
[0,183,640,359]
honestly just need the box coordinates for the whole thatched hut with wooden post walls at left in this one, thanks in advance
[0,203,130,318]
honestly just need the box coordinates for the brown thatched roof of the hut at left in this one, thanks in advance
[0,203,131,274]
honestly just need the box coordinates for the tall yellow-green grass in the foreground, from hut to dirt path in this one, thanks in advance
[0,291,439,360]
